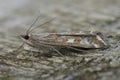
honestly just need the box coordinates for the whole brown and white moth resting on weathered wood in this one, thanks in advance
[21,17,108,54]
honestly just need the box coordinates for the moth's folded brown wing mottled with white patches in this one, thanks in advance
[31,33,107,48]
